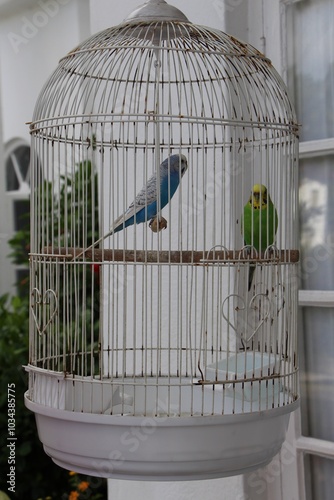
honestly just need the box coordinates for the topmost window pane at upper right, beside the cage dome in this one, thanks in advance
[287,0,334,141]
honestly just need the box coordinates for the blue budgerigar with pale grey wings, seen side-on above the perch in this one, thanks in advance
[106,154,188,236]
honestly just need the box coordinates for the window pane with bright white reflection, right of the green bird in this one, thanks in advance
[299,156,334,290]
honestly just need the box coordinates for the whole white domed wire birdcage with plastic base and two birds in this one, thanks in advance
[26,0,299,480]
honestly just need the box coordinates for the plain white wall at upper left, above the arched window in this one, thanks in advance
[0,0,89,145]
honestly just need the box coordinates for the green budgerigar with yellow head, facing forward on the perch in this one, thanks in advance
[242,184,278,290]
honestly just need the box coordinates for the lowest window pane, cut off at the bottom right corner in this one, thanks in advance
[304,455,334,500]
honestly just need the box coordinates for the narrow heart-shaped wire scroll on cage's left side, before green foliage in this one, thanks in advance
[31,288,58,335]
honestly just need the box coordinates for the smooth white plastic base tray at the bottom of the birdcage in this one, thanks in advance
[25,392,299,481]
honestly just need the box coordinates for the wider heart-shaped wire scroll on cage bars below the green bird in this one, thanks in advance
[222,293,271,344]
